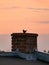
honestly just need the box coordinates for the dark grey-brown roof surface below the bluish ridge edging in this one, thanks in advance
[0,57,49,65]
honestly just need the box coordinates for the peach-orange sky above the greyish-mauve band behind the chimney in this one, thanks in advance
[0,0,49,34]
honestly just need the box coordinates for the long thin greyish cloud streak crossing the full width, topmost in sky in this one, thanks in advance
[0,6,49,11]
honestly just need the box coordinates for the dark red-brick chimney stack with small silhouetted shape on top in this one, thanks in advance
[11,30,38,53]
